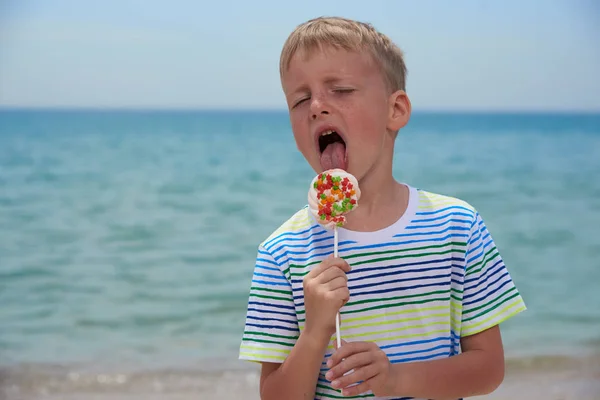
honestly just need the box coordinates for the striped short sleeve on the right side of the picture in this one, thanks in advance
[461,213,526,336]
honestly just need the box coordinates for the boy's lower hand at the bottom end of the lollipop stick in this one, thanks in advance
[325,341,394,397]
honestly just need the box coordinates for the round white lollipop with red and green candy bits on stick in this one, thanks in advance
[308,169,360,348]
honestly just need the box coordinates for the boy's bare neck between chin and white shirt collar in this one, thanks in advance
[344,159,409,232]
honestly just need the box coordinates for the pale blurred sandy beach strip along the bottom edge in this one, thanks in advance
[2,357,600,400]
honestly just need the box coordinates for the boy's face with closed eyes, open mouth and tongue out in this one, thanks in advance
[282,48,408,180]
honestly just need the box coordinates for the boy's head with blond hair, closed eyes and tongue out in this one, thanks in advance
[280,18,410,180]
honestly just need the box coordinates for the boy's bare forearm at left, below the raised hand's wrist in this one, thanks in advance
[260,331,329,400]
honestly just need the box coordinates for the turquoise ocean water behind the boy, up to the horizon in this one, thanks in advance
[0,110,600,394]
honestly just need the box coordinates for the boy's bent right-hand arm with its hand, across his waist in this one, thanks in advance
[328,326,504,400]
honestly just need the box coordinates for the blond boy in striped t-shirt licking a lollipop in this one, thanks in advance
[240,18,525,400]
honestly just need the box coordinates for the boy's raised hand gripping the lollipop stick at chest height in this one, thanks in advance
[303,257,350,339]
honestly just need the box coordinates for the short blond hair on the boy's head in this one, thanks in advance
[279,17,407,92]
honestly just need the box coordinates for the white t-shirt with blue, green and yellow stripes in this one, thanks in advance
[240,187,525,399]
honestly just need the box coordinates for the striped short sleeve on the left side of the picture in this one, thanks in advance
[239,246,300,363]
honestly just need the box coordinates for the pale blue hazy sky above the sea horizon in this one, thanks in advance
[0,0,600,111]
